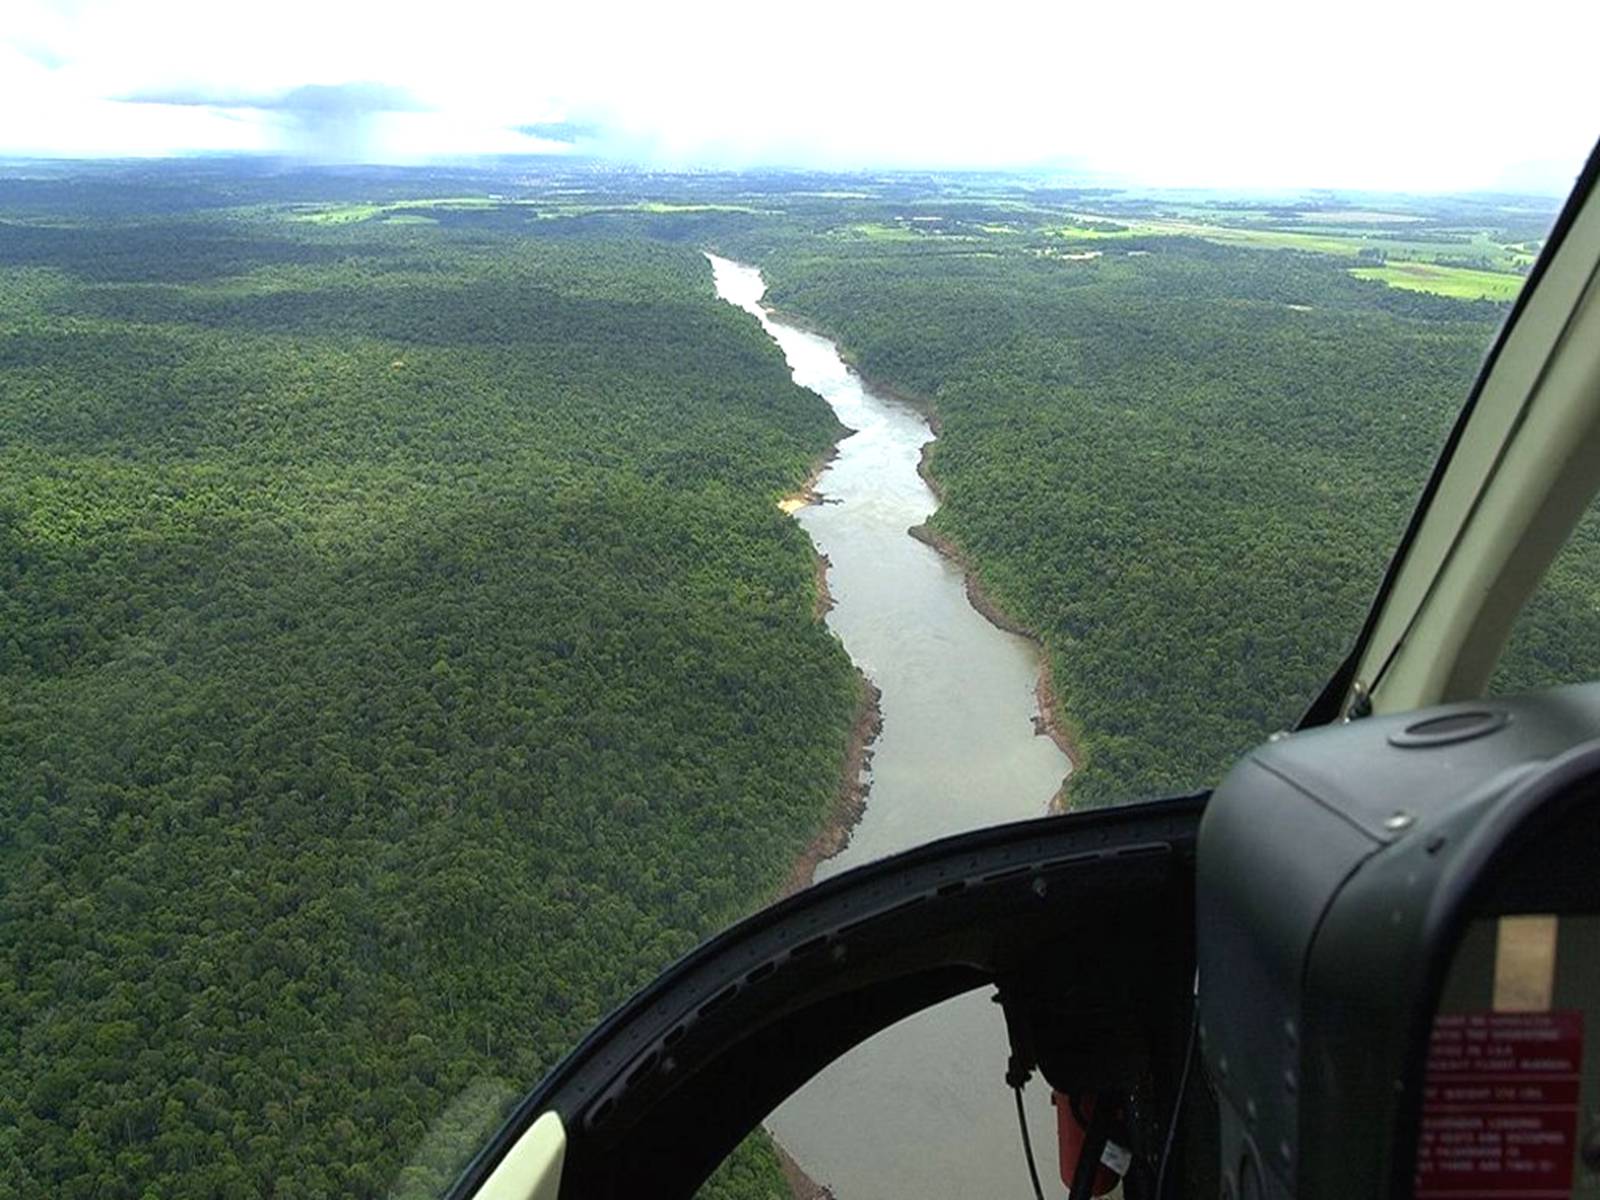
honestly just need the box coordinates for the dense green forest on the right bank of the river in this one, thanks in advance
[722,211,1600,805]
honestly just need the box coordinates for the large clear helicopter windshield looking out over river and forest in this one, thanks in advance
[0,0,1600,1200]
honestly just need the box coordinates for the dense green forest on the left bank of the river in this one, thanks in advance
[0,184,858,1198]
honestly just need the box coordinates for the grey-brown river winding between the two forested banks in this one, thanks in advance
[707,254,1070,1200]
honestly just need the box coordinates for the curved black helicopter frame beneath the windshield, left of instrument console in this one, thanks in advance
[448,794,1206,1200]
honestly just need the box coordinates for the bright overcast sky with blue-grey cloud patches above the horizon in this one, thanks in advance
[0,0,1600,192]
